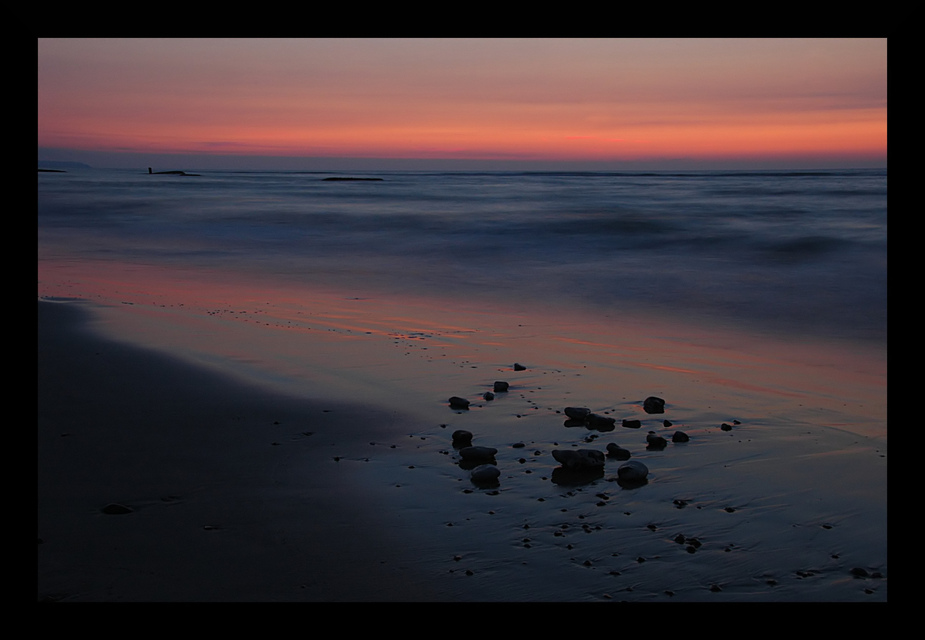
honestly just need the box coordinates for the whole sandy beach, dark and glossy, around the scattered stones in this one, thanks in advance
[38,260,887,602]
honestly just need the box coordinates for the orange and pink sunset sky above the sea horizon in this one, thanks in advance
[38,38,887,169]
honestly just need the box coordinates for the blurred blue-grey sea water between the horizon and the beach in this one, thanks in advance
[38,169,887,345]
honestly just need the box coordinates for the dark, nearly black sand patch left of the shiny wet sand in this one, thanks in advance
[38,302,460,601]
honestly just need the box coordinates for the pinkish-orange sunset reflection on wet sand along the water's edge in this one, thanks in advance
[38,259,886,434]
